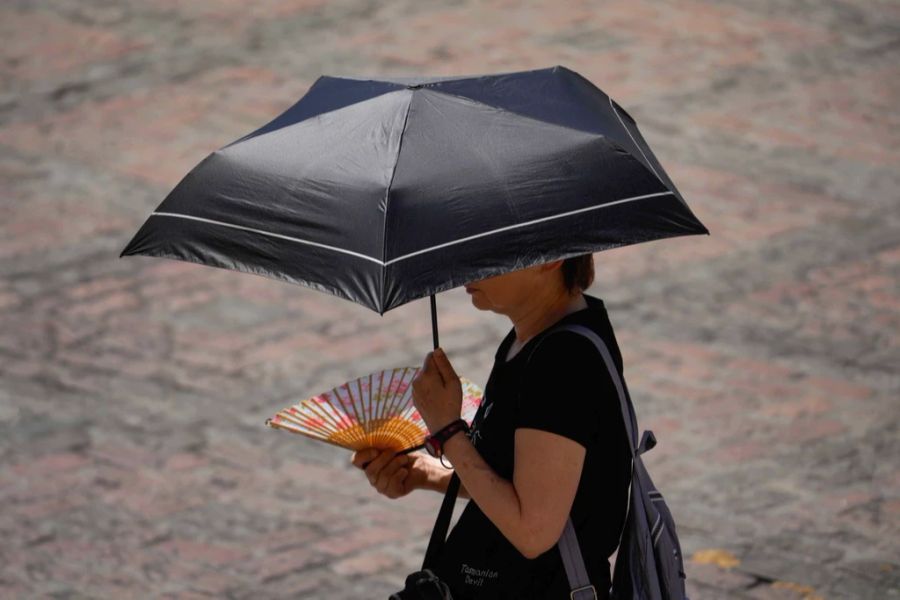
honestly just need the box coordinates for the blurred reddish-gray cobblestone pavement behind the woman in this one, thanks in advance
[0,0,900,600]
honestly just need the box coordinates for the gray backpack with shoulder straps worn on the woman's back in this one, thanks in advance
[545,325,688,600]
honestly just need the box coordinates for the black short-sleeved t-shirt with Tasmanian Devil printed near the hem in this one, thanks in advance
[436,294,631,600]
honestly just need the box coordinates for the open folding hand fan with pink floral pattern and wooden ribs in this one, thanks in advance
[266,367,483,451]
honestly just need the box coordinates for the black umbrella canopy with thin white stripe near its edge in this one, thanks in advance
[121,66,709,314]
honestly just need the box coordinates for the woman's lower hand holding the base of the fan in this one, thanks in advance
[350,448,430,499]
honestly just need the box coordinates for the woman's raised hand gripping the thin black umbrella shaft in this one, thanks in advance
[412,348,462,433]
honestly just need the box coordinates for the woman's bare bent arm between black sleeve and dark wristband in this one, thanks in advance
[444,428,585,558]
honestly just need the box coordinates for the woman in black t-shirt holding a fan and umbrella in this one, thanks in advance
[352,254,631,600]
